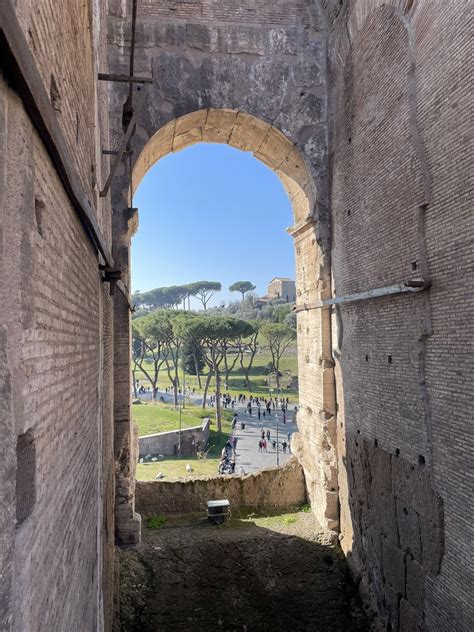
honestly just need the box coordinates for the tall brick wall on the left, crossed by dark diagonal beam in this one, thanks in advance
[0,0,114,632]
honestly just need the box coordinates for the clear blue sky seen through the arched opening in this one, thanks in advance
[132,143,295,307]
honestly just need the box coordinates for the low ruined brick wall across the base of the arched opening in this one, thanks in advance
[135,457,306,516]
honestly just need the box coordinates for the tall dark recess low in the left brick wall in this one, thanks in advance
[16,430,36,525]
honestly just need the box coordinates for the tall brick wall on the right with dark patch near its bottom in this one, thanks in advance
[323,0,474,631]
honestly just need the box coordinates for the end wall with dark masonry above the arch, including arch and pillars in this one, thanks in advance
[109,0,338,542]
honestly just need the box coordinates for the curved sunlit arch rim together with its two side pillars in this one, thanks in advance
[115,103,337,541]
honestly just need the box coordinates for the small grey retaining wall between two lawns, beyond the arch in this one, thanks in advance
[139,417,211,457]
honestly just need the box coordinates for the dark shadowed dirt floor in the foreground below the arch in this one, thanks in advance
[117,512,369,632]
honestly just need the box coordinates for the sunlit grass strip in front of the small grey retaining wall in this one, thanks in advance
[134,406,233,481]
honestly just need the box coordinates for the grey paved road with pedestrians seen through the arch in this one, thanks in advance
[134,391,298,474]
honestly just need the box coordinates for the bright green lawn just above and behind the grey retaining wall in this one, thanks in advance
[132,402,206,437]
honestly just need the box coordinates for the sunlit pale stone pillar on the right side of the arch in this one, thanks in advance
[289,217,339,529]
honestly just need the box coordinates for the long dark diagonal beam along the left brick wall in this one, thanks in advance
[0,0,114,268]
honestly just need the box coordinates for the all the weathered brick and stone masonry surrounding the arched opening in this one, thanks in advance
[0,0,474,632]
